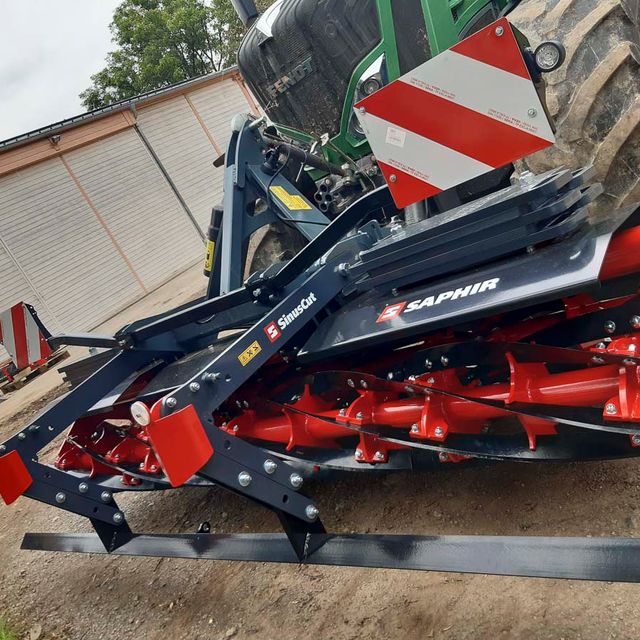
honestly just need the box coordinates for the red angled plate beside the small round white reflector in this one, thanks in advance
[147,404,213,487]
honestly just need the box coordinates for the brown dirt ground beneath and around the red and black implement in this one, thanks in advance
[0,271,640,640]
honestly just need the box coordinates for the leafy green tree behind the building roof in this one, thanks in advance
[80,0,273,110]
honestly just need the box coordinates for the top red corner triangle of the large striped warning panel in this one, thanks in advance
[451,18,531,80]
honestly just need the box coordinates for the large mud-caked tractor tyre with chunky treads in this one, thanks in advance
[509,0,640,214]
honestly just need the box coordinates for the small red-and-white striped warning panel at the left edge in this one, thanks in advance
[0,302,51,370]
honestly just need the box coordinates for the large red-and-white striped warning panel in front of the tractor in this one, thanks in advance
[356,18,555,208]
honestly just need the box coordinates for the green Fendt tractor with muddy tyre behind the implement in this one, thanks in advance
[232,0,640,269]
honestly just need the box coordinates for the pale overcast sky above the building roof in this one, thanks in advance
[0,0,120,140]
